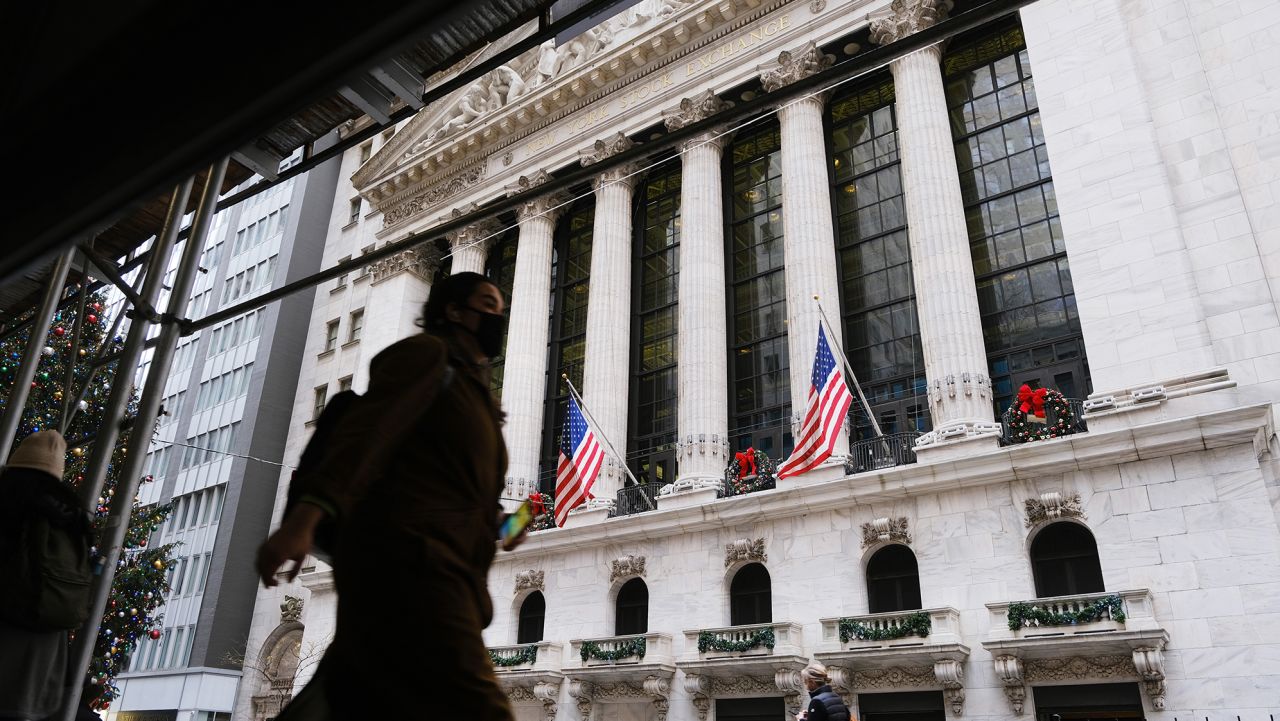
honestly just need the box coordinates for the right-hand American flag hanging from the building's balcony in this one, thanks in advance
[778,323,854,478]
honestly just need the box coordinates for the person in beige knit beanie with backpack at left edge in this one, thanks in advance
[0,430,92,721]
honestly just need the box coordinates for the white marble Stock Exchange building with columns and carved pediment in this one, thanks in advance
[238,0,1280,721]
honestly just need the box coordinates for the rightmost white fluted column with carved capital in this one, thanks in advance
[870,0,1000,447]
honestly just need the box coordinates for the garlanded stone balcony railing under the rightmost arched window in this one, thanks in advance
[987,590,1156,639]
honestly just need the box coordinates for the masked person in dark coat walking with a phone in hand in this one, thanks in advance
[259,273,524,721]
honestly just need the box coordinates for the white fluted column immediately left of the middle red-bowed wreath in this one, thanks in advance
[663,91,728,483]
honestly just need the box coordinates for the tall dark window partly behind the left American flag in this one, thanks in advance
[539,196,595,493]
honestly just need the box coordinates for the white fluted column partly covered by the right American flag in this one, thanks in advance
[760,42,849,458]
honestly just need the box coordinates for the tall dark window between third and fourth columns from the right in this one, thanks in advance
[627,160,681,483]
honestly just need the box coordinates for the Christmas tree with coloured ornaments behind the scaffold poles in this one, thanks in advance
[0,283,174,709]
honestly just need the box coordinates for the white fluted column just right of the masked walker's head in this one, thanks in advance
[502,172,568,498]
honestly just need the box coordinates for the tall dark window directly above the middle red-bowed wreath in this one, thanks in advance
[727,122,792,458]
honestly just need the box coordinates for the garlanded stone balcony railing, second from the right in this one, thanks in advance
[822,608,960,651]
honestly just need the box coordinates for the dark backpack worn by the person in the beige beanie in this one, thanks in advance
[0,469,93,631]
